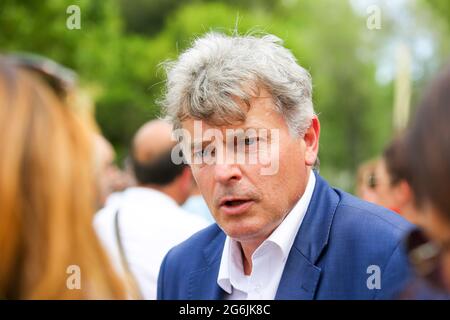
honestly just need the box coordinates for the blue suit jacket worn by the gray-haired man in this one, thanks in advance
[158,174,412,299]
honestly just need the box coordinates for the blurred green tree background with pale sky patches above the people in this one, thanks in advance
[0,0,450,191]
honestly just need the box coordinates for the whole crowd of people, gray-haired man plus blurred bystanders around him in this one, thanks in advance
[0,33,450,299]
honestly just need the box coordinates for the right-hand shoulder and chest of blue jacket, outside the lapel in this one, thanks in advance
[317,189,413,299]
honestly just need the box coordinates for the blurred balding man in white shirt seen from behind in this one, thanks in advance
[95,120,208,299]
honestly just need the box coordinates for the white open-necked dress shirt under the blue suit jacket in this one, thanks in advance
[217,171,316,300]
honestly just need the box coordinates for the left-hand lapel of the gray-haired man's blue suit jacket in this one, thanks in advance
[188,226,225,300]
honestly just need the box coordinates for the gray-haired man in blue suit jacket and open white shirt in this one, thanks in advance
[158,33,410,299]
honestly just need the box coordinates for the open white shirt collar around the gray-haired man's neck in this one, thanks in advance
[217,171,316,294]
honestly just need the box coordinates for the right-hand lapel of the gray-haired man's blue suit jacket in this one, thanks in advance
[275,172,339,300]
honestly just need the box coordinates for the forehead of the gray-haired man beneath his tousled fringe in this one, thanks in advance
[181,89,288,134]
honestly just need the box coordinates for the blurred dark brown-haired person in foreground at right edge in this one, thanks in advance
[396,67,450,299]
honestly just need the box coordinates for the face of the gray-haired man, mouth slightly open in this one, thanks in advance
[182,90,320,242]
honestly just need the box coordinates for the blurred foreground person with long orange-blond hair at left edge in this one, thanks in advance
[0,57,125,299]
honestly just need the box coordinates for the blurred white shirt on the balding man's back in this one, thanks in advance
[94,187,208,299]
